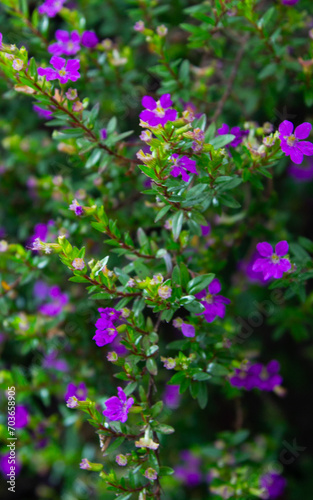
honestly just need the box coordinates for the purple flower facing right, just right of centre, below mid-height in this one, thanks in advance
[196,278,230,323]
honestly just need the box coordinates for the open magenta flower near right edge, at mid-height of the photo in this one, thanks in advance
[252,241,291,280]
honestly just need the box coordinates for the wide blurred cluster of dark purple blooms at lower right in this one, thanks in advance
[230,359,283,391]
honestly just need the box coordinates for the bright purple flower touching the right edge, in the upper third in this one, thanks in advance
[278,120,313,165]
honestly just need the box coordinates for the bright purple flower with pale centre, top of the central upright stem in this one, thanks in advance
[140,94,177,127]
